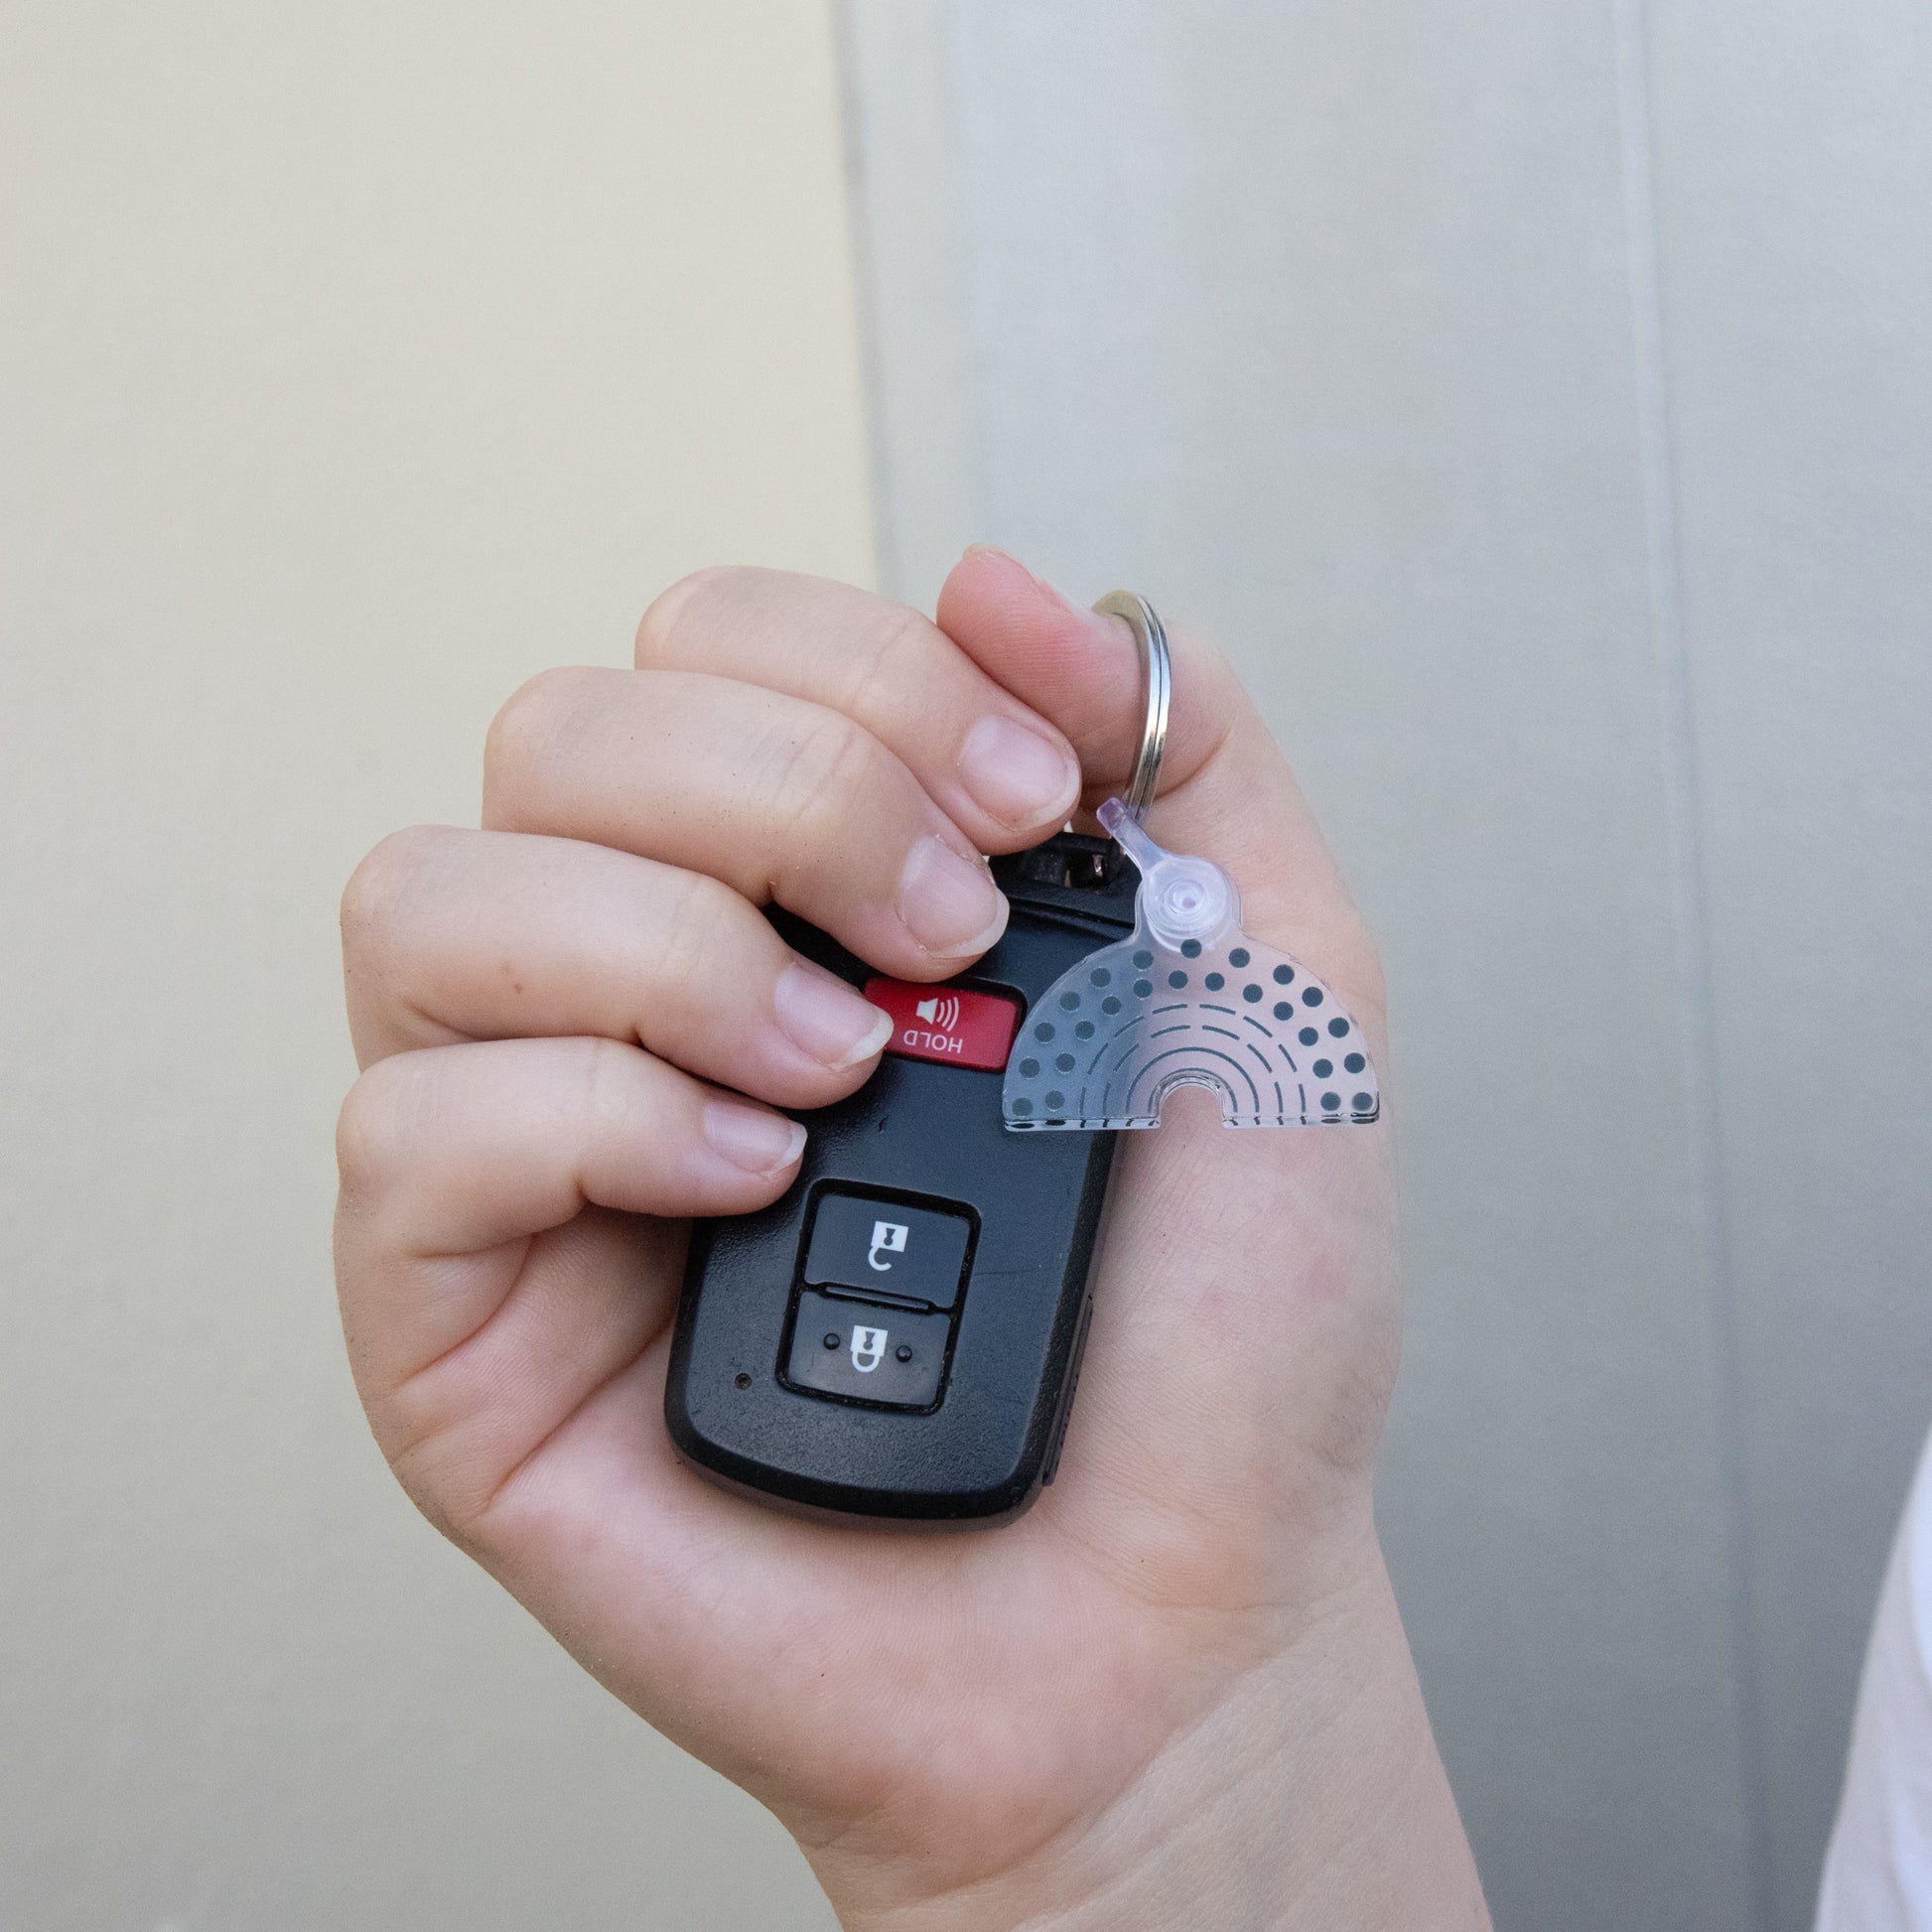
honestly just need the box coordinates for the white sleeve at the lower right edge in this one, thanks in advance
[1818,1444,1932,1932]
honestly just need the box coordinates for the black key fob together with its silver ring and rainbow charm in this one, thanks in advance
[664,591,1381,1522]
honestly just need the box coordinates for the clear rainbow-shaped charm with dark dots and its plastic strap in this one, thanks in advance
[1003,798,1381,1132]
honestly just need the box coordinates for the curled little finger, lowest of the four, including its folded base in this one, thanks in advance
[337,1039,805,1524]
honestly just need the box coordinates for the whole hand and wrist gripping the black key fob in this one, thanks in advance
[339,551,1487,1932]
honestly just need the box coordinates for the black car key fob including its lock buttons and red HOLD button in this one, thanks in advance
[664,833,1140,1522]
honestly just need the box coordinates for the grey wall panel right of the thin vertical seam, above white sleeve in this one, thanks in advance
[1654,0,1932,1928]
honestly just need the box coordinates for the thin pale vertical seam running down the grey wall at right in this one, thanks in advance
[1611,0,1777,1932]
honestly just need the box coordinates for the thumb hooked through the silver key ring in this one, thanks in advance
[939,547,1383,1034]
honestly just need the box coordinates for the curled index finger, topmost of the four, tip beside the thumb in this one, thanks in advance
[635,570,1080,852]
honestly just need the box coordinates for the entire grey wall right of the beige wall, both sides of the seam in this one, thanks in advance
[850,0,1932,1928]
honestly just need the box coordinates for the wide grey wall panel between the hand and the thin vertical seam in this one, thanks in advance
[927,18,1748,1928]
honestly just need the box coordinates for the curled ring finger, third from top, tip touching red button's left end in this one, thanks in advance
[342,825,893,1107]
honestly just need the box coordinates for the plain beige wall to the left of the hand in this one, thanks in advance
[0,0,872,1932]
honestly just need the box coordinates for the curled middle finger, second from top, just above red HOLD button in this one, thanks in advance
[483,670,1007,980]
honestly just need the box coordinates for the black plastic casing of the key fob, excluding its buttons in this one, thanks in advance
[664,833,1140,1524]
